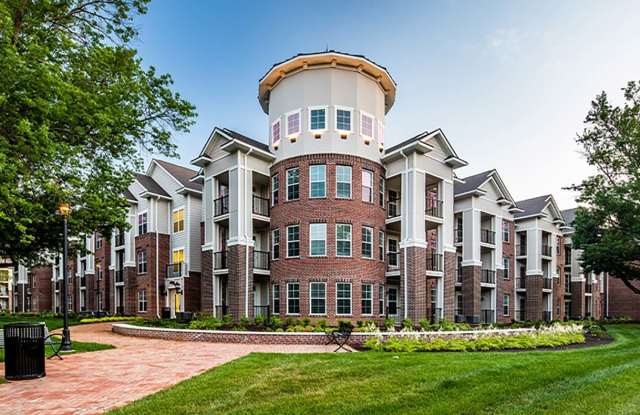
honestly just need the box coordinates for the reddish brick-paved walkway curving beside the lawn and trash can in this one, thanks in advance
[0,323,340,415]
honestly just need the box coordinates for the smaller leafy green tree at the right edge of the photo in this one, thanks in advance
[572,82,640,294]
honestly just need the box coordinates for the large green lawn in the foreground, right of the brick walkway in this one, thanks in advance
[113,325,640,415]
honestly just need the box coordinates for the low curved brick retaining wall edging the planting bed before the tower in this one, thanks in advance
[111,323,535,347]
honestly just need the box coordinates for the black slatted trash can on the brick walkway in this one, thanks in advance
[4,323,45,380]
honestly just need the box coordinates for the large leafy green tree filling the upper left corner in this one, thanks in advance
[0,0,195,259]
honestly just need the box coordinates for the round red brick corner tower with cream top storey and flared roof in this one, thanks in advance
[259,51,396,323]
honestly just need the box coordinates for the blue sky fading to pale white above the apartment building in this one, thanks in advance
[132,0,640,209]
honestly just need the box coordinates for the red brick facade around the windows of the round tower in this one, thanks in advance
[268,154,384,321]
